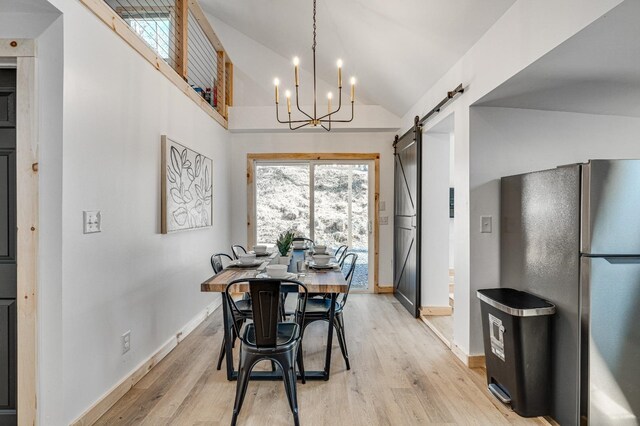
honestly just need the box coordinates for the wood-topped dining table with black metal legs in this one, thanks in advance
[200,249,348,380]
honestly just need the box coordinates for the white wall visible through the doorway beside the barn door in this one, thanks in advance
[420,133,451,307]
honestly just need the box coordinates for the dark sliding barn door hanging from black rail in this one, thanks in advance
[393,125,422,317]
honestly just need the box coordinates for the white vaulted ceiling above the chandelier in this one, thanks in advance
[200,0,515,116]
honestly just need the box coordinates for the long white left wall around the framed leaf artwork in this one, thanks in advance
[0,0,231,426]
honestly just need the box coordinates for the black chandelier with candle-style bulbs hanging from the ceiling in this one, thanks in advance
[273,0,356,131]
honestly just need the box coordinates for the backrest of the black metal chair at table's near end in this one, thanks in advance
[225,278,308,348]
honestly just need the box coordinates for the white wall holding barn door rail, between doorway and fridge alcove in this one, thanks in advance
[401,0,622,354]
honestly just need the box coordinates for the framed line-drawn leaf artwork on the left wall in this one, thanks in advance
[161,135,213,234]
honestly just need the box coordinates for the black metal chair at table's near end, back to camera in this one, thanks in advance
[225,278,308,426]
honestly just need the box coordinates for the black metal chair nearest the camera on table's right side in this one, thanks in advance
[296,253,358,370]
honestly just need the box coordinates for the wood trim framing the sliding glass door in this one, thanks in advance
[247,152,380,293]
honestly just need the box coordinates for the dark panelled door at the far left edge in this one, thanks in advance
[0,69,16,425]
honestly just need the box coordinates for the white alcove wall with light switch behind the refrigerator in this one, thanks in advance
[468,107,640,353]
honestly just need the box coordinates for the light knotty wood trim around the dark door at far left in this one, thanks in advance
[0,39,39,425]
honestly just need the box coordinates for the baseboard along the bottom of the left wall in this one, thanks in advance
[71,299,221,426]
